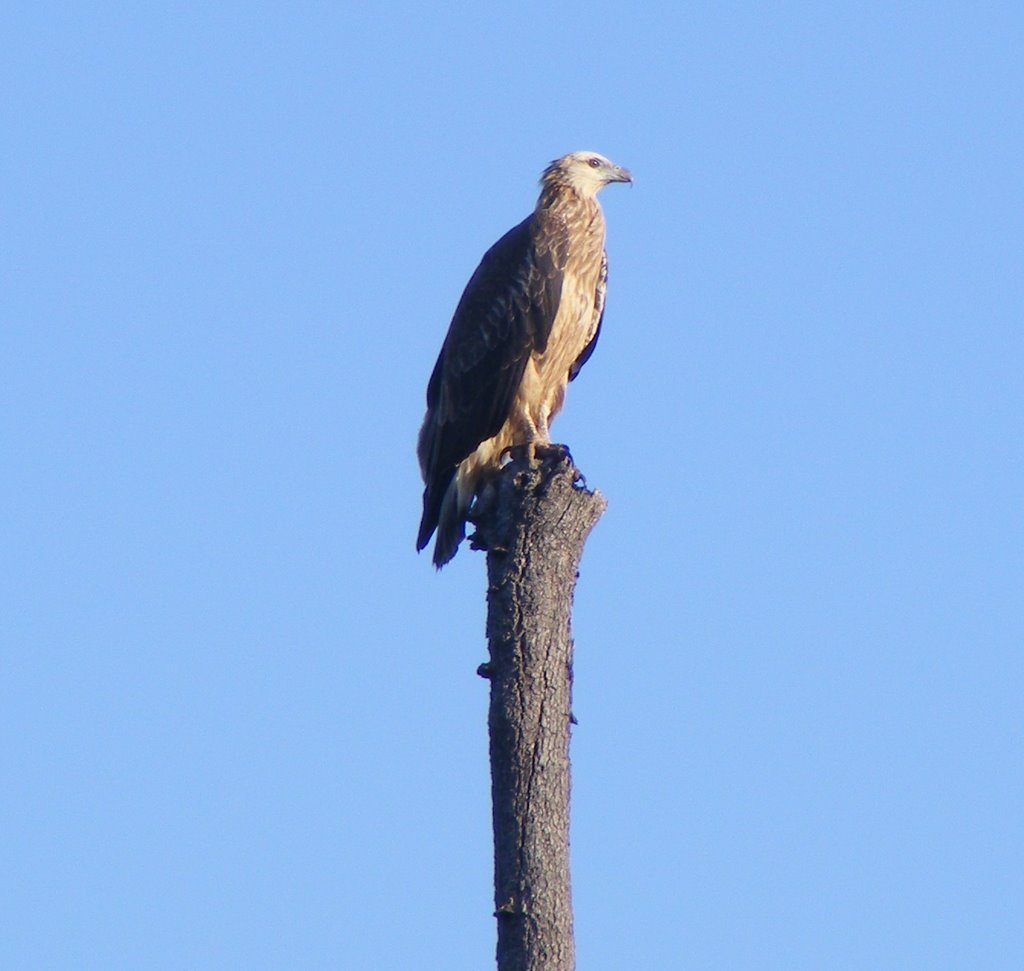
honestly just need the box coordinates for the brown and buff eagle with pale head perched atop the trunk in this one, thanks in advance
[416,152,633,568]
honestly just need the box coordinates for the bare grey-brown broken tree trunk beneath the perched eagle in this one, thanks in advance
[473,456,605,971]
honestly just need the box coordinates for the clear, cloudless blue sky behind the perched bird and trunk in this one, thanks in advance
[0,0,1024,971]
